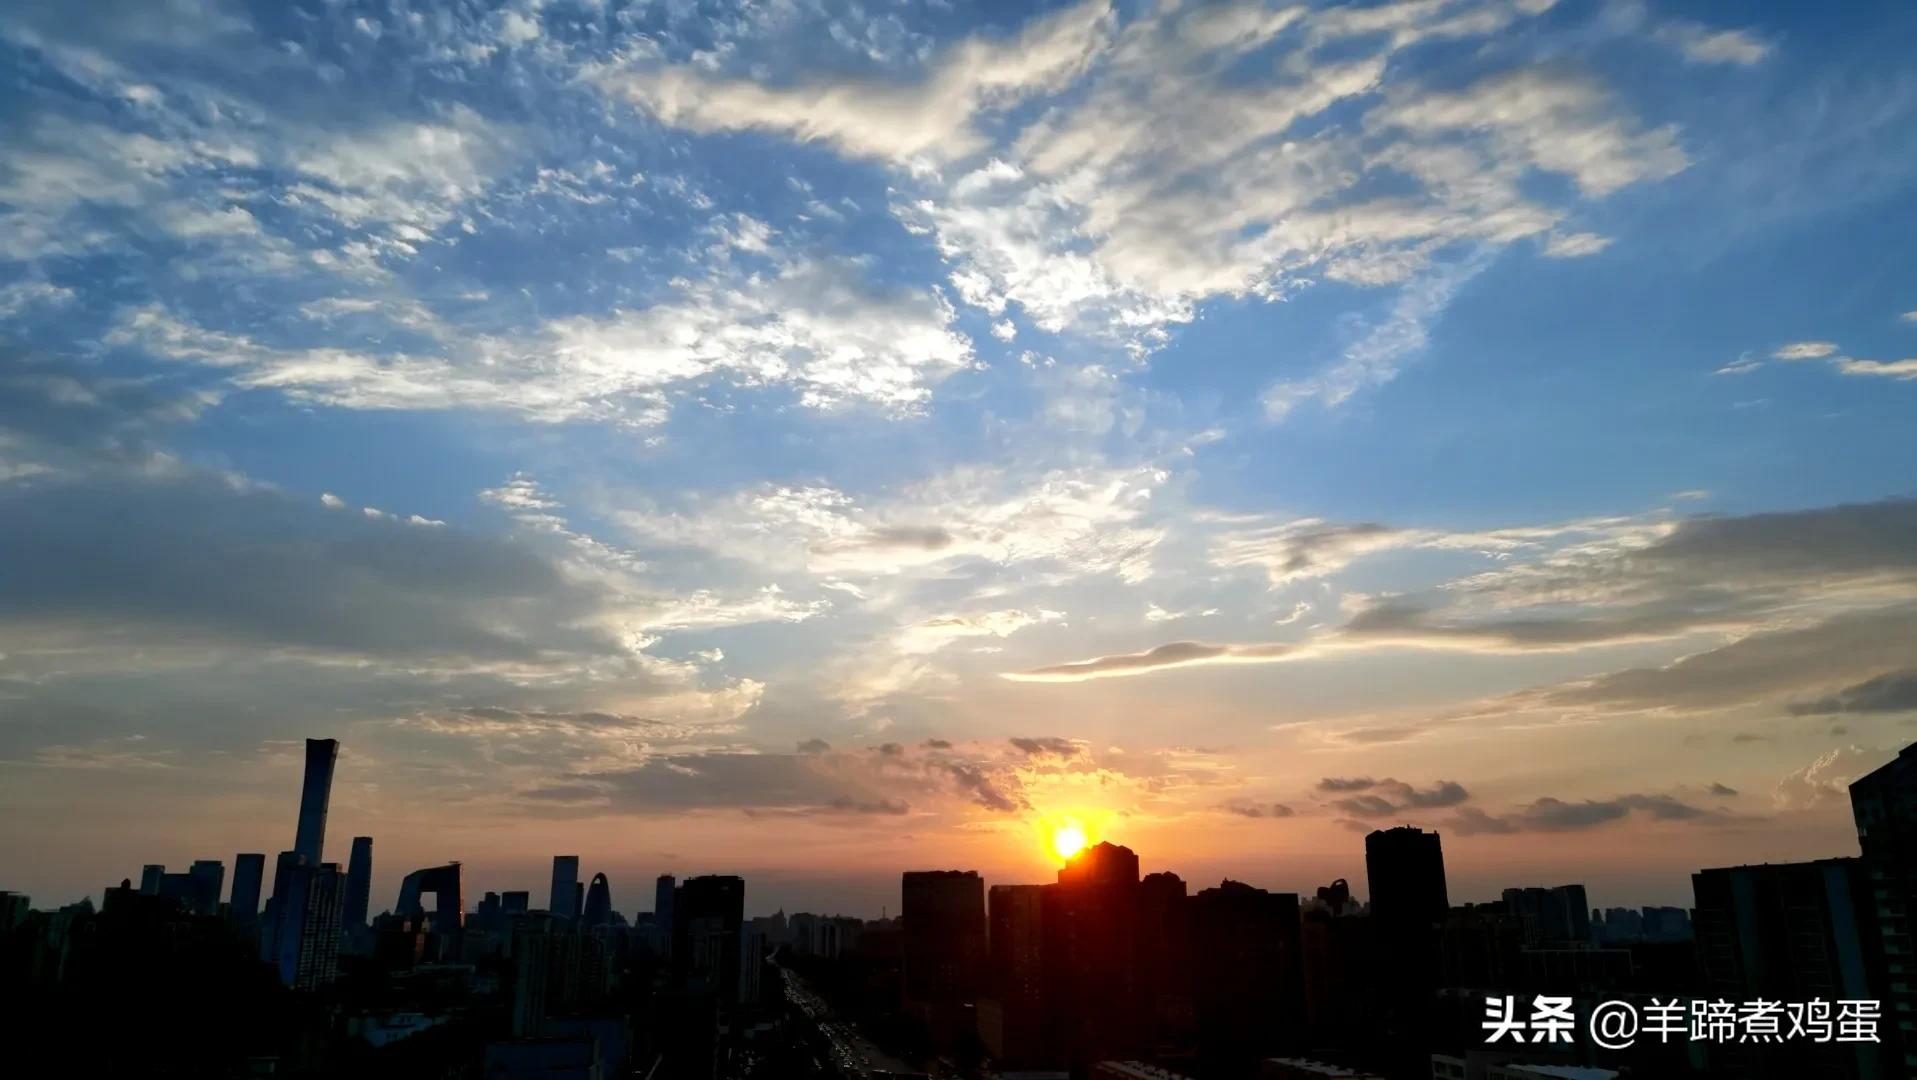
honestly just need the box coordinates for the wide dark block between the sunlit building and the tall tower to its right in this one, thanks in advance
[1190,880,1305,1074]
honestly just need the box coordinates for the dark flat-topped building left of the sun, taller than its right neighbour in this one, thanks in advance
[899,871,985,1045]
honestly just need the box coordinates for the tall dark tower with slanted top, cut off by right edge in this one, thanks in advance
[1850,742,1917,1076]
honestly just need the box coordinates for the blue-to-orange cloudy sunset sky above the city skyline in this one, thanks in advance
[0,0,1917,915]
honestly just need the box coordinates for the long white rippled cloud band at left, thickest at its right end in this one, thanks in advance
[107,253,974,424]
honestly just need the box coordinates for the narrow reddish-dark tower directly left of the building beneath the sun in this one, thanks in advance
[981,884,1052,1068]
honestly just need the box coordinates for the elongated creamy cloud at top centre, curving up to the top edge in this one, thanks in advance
[587,0,1110,159]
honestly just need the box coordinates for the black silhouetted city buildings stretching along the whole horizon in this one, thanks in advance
[11,739,1917,1080]
